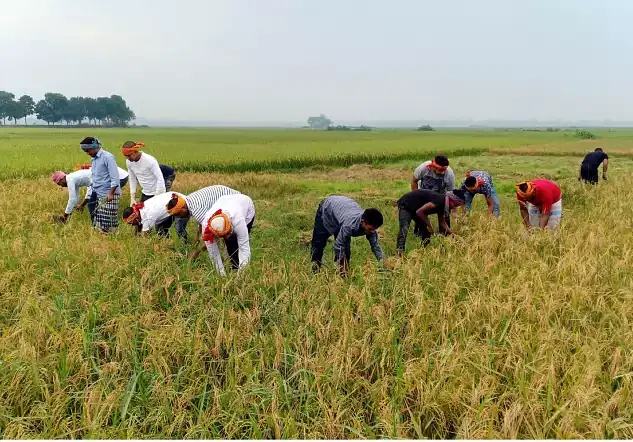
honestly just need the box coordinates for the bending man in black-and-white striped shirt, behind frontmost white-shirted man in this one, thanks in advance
[166,185,240,243]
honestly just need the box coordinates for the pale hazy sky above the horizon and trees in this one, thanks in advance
[0,0,633,122]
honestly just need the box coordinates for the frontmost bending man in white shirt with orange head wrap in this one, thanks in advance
[183,194,255,276]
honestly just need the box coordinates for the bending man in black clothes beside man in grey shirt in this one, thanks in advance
[396,189,465,255]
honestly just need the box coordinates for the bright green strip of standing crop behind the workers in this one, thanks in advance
[0,128,615,179]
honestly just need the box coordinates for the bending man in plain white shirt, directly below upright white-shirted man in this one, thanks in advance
[123,192,189,241]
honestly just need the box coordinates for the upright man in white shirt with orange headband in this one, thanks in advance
[121,141,176,205]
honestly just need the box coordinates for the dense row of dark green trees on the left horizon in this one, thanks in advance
[0,91,136,127]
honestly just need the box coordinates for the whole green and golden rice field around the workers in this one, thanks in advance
[0,128,633,439]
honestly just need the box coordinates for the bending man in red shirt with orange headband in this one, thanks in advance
[516,180,563,230]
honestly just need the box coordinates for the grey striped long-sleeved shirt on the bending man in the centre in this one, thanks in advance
[321,195,383,261]
